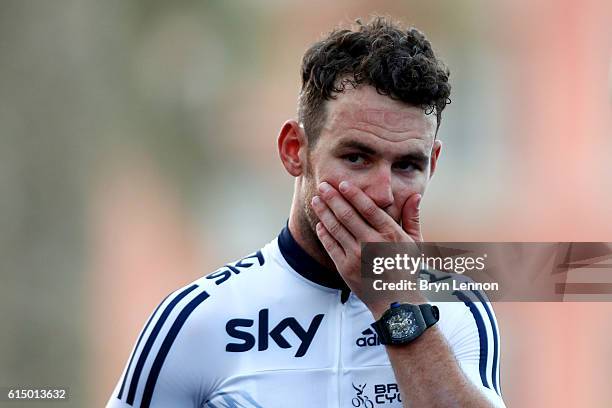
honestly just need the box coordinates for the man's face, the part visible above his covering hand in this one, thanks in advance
[302,86,441,234]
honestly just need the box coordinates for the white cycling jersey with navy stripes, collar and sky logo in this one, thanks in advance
[107,228,504,408]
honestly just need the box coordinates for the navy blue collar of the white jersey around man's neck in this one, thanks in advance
[278,226,349,294]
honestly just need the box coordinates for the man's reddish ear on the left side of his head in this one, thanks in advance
[277,120,308,177]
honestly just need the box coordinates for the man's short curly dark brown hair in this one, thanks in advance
[298,17,451,145]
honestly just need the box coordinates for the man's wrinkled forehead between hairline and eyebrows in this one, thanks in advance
[321,86,436,144]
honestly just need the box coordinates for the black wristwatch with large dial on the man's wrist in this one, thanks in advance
[372,302,440,345]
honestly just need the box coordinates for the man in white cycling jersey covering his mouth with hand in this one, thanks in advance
[108,18,503,408]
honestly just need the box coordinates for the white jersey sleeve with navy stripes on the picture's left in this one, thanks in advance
[106,283,214,408]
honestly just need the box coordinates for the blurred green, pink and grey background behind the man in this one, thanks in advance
[0,0,612,407]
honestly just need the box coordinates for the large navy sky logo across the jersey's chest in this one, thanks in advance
[225,309,324,357]
